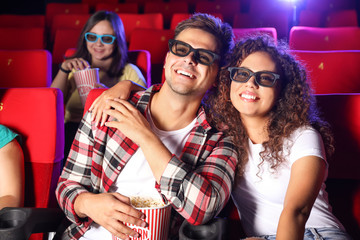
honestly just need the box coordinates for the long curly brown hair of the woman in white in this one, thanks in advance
[204,35,334,175]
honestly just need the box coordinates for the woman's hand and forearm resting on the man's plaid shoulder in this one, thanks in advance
[89,80,139,126]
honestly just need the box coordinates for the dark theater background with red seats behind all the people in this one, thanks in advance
[0,0,360,240]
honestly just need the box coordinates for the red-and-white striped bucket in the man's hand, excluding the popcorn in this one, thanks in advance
[112,197,171,240]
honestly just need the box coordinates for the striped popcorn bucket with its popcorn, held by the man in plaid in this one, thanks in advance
[113,197,171,240]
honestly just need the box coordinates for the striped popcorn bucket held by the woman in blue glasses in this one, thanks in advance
[74,68,100,106]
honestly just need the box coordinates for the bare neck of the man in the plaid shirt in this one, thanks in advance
[150,86,201,131]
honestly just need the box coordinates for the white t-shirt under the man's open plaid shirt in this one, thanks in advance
[80,110,196,240]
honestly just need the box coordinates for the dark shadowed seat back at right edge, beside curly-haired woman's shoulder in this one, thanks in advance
[316,93,360,180]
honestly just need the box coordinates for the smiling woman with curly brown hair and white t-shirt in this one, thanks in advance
[206,36,350,240]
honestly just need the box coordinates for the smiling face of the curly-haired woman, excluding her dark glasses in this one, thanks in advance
[230,52,281,119]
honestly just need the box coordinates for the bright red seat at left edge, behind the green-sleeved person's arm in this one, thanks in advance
[0,88,64,240]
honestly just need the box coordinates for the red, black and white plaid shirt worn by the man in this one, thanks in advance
[56,86,237,239]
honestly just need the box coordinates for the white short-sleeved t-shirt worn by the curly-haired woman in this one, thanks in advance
[232,128,343,236]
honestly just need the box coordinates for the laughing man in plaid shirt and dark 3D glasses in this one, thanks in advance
[56,14,237,240]
